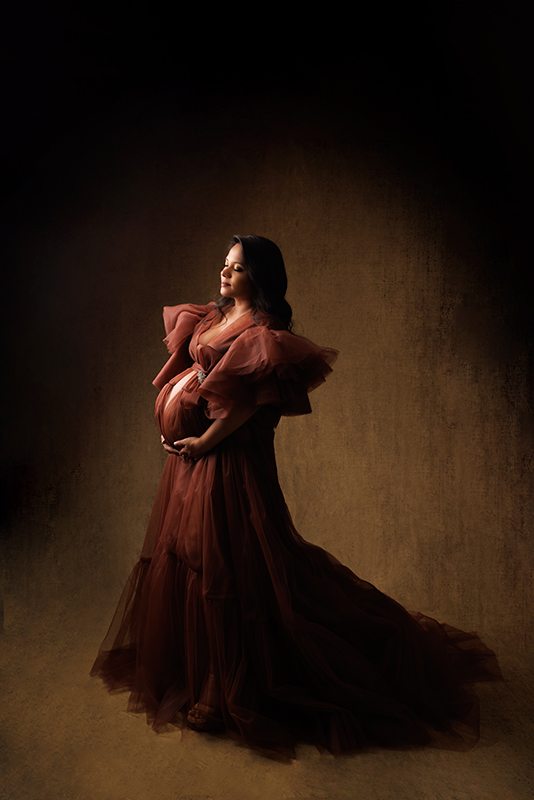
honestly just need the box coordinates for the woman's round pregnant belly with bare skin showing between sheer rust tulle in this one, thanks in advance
[156,370,211,444]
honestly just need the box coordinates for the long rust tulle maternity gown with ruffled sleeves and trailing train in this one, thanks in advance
[91,304,500,759]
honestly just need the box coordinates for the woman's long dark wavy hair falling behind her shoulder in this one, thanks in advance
[217,236,293,330]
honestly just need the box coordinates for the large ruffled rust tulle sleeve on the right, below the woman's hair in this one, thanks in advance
[198,325,338,419]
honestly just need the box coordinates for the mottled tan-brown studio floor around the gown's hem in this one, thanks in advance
[0,600,534,800]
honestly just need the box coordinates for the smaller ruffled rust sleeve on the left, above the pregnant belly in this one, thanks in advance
[153,303,215,389]
